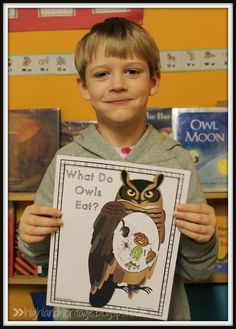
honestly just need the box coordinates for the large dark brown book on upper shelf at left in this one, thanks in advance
[8,108,60,192]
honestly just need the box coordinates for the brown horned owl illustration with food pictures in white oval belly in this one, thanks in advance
[88,170,165,307]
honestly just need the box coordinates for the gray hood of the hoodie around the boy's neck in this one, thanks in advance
[74,124,181,164]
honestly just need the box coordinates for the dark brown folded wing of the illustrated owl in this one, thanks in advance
[89,201,126,293]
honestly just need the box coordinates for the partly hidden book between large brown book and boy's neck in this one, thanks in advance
[60,120,97,147]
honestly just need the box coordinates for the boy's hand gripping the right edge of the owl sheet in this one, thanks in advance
[174,203,216,243]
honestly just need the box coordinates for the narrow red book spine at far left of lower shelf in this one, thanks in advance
[8,201,15,277]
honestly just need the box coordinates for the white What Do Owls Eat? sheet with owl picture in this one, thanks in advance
[47,156,190,320]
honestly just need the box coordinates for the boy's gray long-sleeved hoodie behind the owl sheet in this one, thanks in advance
[19,125,217,321]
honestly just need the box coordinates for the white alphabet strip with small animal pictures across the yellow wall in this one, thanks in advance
[8,49,228,76]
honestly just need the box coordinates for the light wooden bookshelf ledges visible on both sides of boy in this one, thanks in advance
[8,192,228,286]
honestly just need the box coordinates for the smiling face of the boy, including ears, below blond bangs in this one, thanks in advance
[79,46,159,127]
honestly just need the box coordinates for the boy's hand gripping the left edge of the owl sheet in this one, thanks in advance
[19,204,63,243]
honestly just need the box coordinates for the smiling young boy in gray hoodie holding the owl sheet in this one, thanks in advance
[20,18,217,320]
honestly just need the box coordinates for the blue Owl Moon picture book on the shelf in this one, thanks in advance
[172,108,228,192]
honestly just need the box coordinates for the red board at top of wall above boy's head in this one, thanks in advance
[8,8,143,32]
